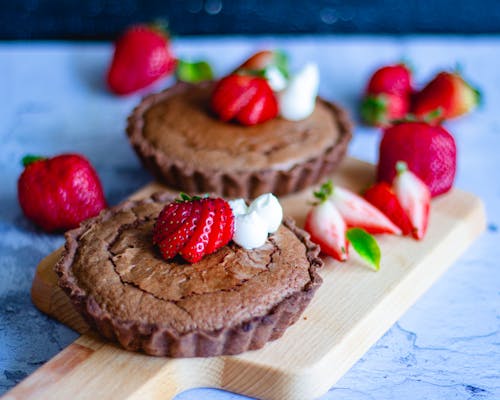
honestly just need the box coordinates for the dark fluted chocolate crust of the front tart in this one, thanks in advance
[55,193,323,357]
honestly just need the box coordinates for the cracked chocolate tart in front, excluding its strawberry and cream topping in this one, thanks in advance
[55,194,322,357]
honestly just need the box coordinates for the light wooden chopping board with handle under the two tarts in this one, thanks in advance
[4,159,485,400]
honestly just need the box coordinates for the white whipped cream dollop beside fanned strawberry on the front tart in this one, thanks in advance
[229,193,283,250]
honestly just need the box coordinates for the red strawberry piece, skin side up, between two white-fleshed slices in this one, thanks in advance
[364,182,413,235]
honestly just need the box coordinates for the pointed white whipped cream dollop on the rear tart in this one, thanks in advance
[278,63,319,121]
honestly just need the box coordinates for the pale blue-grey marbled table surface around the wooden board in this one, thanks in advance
[0,36,500,400]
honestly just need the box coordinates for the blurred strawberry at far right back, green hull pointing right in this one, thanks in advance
[413,72,481,122]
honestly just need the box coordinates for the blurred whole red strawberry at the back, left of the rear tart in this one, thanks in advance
[107,25,175,95]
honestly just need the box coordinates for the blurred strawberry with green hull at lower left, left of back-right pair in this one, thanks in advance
[361,64,413,126]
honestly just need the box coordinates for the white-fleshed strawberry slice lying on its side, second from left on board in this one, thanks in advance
[326,181,401,235]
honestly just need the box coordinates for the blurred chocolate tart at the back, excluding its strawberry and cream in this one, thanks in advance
[127,82,352,198]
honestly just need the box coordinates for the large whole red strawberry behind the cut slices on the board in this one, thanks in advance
[377,122,457,196]
